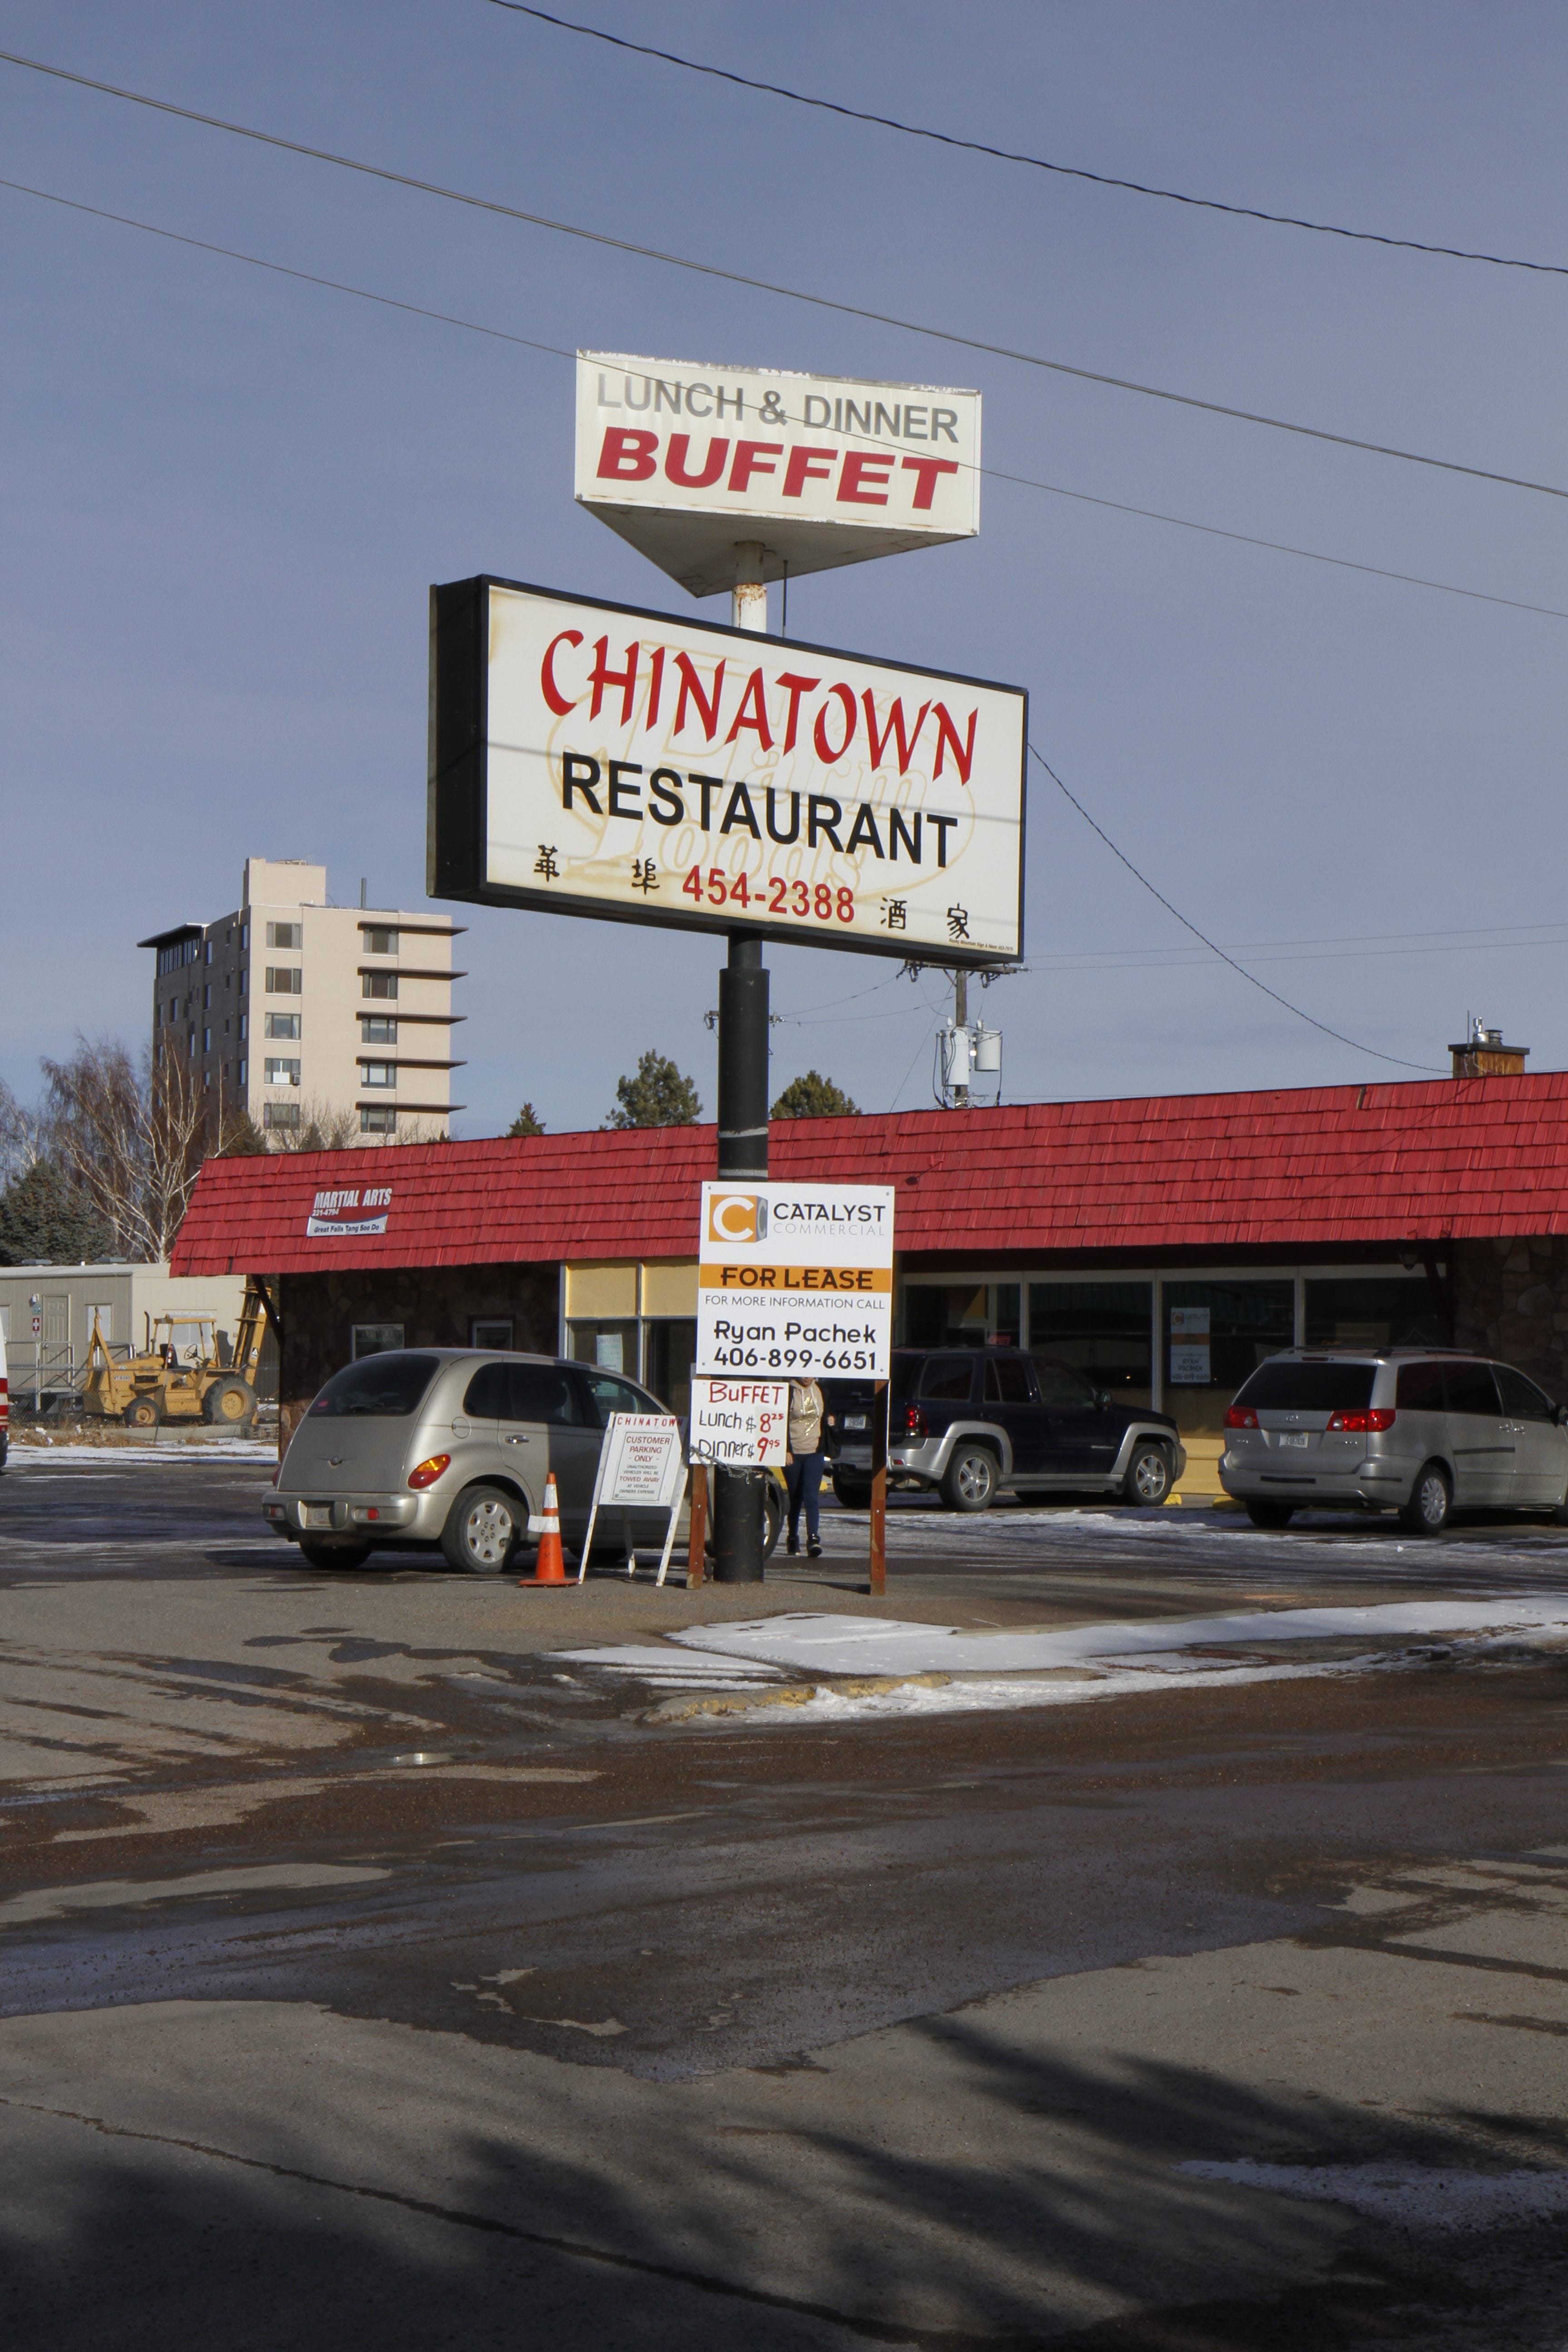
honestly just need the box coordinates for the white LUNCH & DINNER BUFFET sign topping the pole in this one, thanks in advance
[576,350,980,595]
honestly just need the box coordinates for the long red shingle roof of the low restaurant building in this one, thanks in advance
[172,1070,1568,1275]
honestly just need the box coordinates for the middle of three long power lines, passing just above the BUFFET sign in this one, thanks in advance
[0,49,1568,499]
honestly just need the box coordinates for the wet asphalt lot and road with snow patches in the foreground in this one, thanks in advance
[0,1446,1568,2352]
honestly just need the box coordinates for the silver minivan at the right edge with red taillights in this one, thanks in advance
[1220,1348,1568,1536]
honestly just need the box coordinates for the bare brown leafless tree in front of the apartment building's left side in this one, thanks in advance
[42,1033,207,1261]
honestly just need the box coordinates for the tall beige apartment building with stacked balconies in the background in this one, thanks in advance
[137,858,466,1143]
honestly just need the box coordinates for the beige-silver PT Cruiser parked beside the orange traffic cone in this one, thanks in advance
[261,1348,668,1576]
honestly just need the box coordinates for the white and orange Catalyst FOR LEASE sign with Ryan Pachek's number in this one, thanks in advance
[691,1183,893,1381]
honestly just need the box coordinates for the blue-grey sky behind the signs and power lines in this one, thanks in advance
[0,0,1568,1134]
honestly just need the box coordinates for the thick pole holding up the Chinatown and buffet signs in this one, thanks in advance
[710,541,769,1585]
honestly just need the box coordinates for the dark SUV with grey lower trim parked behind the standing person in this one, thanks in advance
[830,1348,1187,1510]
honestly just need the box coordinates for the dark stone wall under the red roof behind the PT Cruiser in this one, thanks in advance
[277,1265,559,1454]
